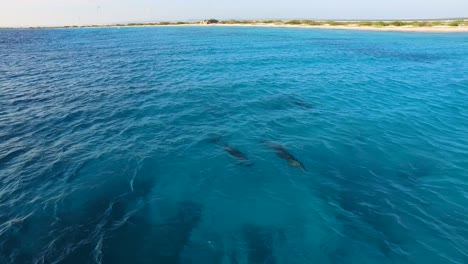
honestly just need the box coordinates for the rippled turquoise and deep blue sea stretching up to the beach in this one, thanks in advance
[0,27,468,264]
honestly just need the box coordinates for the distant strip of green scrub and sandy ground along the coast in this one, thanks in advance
[5,19,468,29]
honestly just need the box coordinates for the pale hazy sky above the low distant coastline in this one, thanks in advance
[0,0,468,27]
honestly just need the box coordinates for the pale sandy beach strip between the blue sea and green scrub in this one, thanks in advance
[0,22,468,33]
